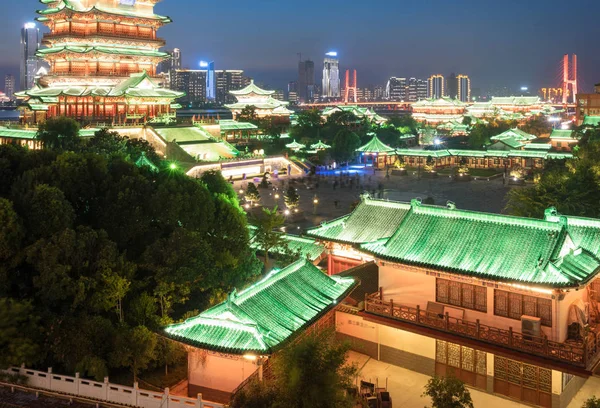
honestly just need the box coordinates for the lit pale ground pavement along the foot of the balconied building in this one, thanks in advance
[349,351,600,408]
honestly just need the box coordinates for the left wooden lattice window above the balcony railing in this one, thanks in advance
[435,278,487,313]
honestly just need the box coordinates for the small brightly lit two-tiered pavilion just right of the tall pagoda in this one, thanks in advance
[225,80,293,122]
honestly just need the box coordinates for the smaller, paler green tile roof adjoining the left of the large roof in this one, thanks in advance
[307,197,411,244]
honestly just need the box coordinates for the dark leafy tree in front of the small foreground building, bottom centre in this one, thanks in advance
[231,331,357,408]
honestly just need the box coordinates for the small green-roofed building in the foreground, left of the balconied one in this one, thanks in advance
[164,259,358,403]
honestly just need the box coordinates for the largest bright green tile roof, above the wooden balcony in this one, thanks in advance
[361,200,600,287]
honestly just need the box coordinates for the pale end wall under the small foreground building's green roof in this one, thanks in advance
[188,349,258,392]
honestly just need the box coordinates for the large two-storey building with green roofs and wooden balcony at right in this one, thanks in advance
[308,197,600,408]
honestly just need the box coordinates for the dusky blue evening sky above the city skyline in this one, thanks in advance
[0,0,600,91]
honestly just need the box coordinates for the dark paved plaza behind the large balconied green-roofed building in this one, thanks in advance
[234,163,523,233]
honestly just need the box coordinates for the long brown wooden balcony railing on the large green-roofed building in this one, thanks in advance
[365,292,600,368]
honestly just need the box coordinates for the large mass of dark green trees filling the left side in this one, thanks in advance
[0,120,260,379]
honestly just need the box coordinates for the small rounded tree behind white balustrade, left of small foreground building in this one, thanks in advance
[111,326,157,382]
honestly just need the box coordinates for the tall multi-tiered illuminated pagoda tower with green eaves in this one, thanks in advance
[18,0,184,122]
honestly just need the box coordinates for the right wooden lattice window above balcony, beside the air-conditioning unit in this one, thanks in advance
[494,289,552,327]
